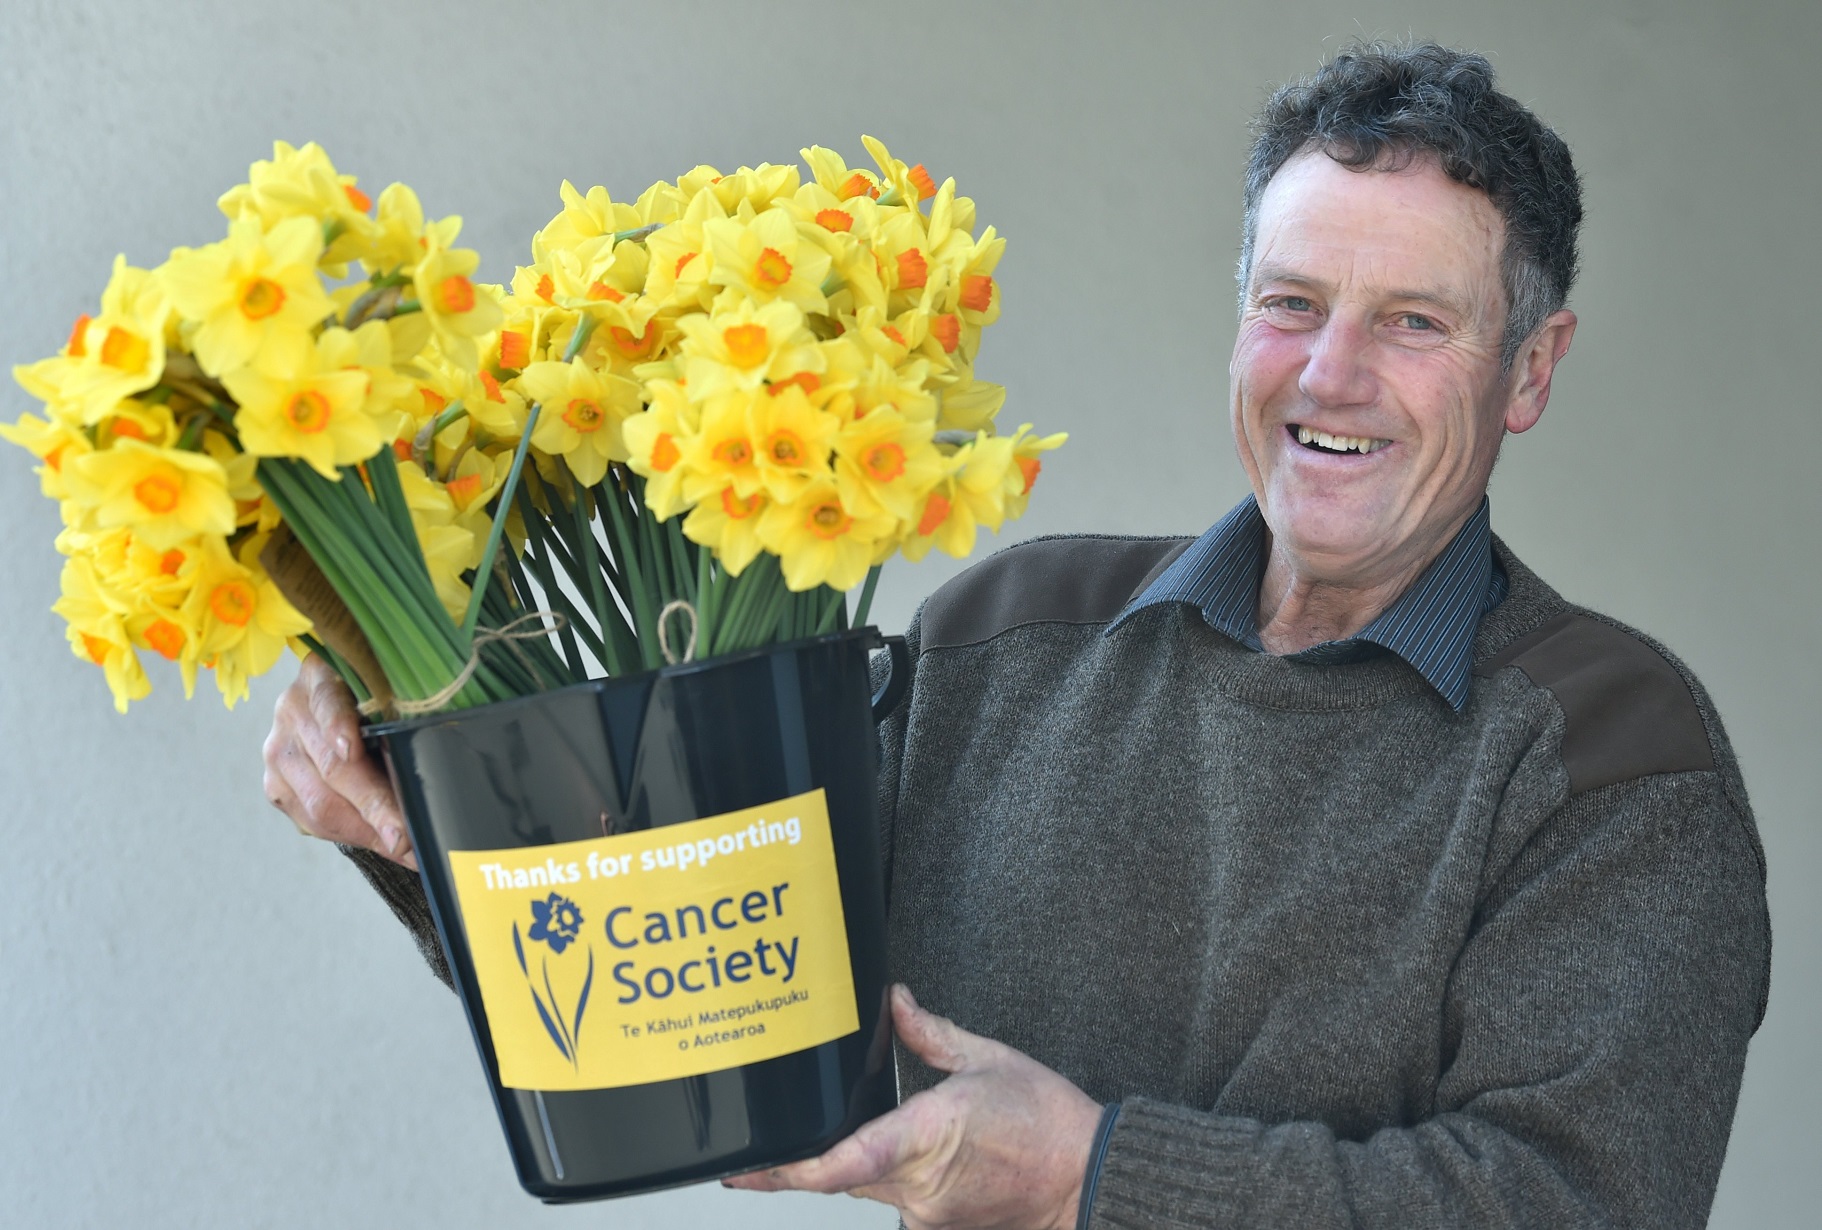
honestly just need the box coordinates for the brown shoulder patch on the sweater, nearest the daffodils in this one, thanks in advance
[918,536,1195,649]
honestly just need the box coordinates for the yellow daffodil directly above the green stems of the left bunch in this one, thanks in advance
[222,348,388,481]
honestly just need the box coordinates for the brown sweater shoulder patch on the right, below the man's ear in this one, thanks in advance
[1474,612,1715,794]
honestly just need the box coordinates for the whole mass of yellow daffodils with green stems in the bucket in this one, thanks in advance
[0,138,1062,712]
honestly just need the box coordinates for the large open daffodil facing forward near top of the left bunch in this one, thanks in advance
[159,217,333,377]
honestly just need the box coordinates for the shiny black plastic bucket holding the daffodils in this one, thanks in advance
[368,629,907,1201]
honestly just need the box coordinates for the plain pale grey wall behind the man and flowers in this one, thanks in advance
[0,0,1822,1228]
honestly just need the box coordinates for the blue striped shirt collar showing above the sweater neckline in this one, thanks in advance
[1108,496,1507,712]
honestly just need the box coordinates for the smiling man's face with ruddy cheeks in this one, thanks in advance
[1228,151,1541,583]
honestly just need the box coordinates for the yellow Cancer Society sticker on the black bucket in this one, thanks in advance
[450,789,860,1090]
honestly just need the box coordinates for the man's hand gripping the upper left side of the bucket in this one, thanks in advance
[266,654,417,869]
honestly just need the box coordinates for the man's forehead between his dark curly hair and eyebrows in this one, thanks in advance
[1252,151,1505,301]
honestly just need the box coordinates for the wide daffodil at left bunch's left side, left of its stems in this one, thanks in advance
[64,439,235,548]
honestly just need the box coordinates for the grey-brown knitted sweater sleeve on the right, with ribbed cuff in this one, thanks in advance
[1086,773,1771,1230]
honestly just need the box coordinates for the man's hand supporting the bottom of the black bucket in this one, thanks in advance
[722,986,1100,1230]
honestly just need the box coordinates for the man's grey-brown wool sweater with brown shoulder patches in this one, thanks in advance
[344,538,1769,1230]
